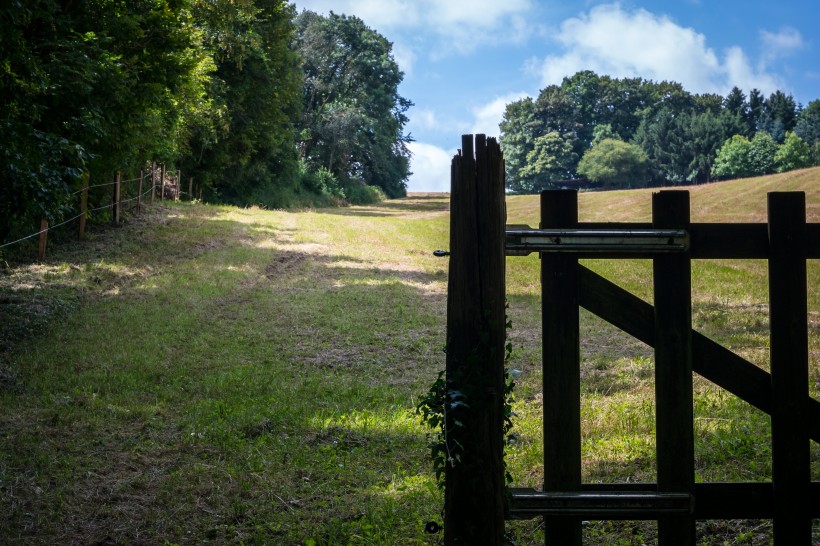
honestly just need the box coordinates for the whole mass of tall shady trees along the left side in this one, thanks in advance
[0,0,411,242]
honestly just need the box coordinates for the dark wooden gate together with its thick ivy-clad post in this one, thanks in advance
[444,135,820,546]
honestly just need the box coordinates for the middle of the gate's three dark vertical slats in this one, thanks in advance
[652,191,695,546]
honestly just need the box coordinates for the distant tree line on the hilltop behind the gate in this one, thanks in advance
[500,71,820,193]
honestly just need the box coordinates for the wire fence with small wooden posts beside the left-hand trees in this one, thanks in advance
[0,165,201,260]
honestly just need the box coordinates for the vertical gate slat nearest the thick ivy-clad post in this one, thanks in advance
[541,190,581,546]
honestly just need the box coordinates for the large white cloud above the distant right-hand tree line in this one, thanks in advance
[529,3,789,94]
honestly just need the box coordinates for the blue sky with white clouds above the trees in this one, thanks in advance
[294,0,820,192]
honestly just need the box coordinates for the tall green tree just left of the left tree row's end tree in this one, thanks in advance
[182,0,301,204]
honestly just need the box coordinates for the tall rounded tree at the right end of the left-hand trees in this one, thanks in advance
[294,11,412,197]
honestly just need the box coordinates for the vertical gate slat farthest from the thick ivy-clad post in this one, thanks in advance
[768,192,812,546]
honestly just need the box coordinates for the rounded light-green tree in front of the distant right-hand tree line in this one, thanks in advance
[578,138,648,188]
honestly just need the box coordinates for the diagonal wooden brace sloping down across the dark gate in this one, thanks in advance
[578,265,820,442]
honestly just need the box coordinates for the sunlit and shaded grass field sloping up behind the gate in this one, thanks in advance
[0,169,820,545]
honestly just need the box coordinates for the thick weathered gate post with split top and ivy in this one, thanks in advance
[444,135,506,546]
